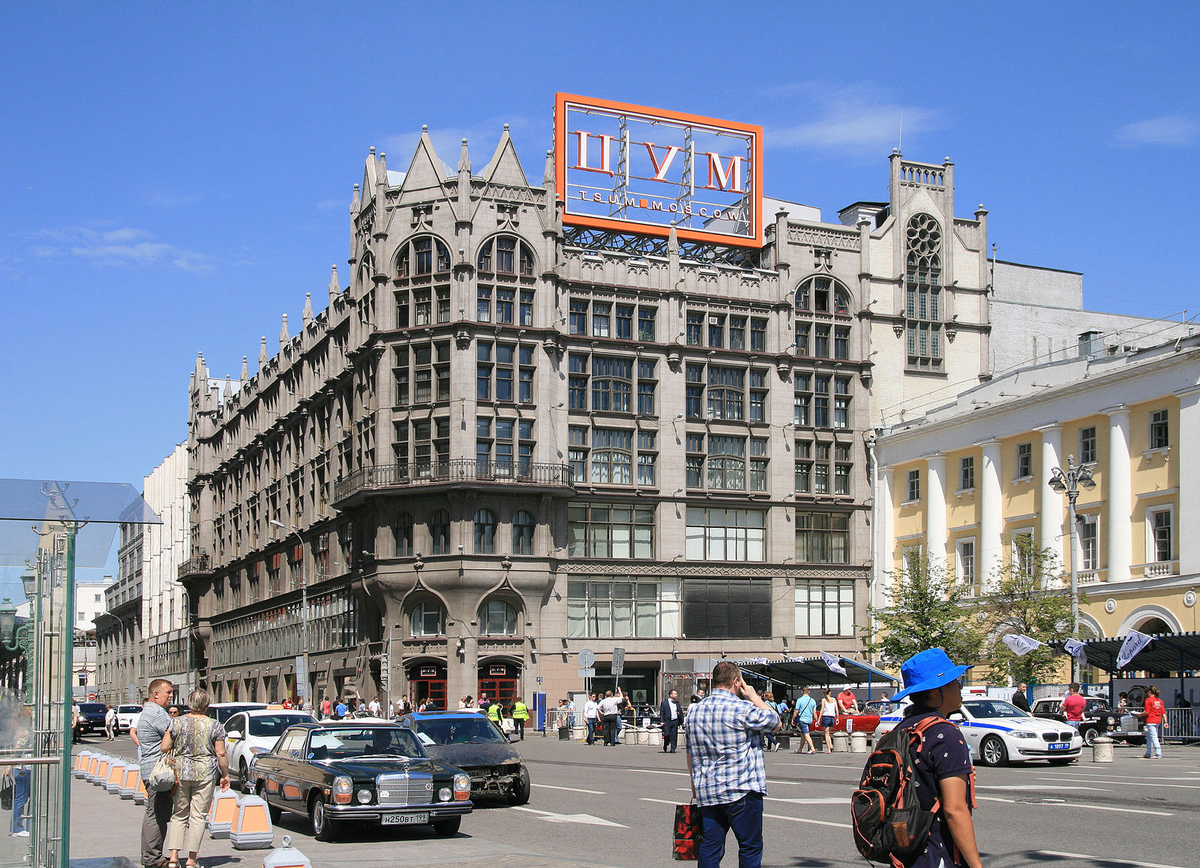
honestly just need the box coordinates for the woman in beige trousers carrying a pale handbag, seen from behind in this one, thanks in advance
[162,688,229,868]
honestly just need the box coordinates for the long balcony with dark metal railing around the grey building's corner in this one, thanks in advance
[334,459,575,505]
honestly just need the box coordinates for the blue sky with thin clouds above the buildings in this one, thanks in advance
[0,8,1200,576]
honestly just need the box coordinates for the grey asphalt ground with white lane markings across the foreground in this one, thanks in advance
[71,735,1200,868]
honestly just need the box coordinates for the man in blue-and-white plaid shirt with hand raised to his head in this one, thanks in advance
[686,660,780,868]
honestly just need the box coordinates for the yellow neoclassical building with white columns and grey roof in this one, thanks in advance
[872,337,1200,637]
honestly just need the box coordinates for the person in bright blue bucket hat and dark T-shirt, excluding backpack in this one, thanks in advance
[894,648,982,868]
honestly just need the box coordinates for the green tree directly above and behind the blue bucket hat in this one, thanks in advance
[865,551,986,668]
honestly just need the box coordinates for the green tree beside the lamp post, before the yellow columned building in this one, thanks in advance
[986,534,1070,684]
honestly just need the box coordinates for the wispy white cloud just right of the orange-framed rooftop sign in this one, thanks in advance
[767,83,941,154]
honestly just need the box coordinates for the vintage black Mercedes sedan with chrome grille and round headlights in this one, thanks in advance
[251,720,473,840]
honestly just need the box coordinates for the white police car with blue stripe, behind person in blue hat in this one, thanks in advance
[875,698,1084,766]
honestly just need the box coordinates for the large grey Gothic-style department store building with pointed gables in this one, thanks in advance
[180,100,1176,707]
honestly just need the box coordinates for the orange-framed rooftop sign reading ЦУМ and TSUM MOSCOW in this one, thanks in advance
[554,94,762,247]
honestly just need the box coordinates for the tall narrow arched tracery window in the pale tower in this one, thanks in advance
[905,214,942,371]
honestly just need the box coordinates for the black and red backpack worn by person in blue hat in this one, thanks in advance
[850,714,947,868]
